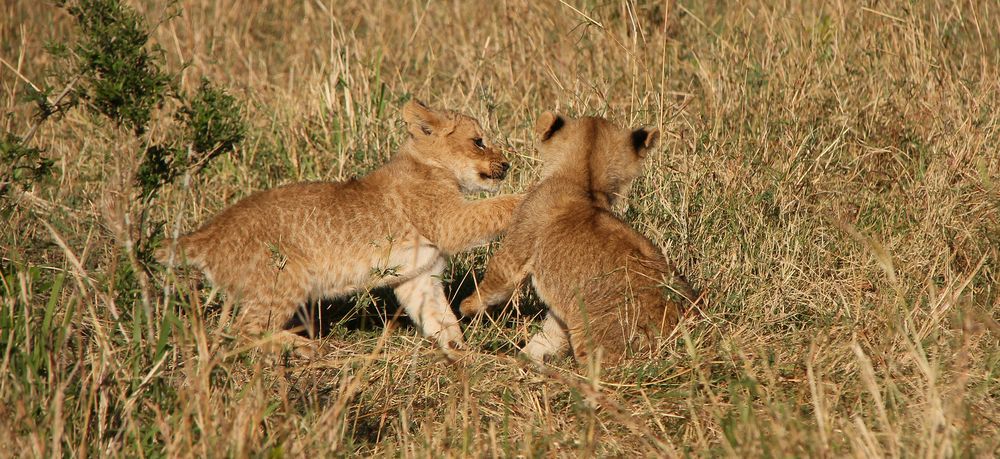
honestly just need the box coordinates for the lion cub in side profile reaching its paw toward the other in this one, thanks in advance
[158,101,521,353]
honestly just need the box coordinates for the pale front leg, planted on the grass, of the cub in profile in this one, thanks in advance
[393,258,465,350]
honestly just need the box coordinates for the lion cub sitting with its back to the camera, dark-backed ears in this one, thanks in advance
[461,112,696,363]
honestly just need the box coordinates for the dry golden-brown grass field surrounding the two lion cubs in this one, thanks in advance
[0,0,1000,457]
